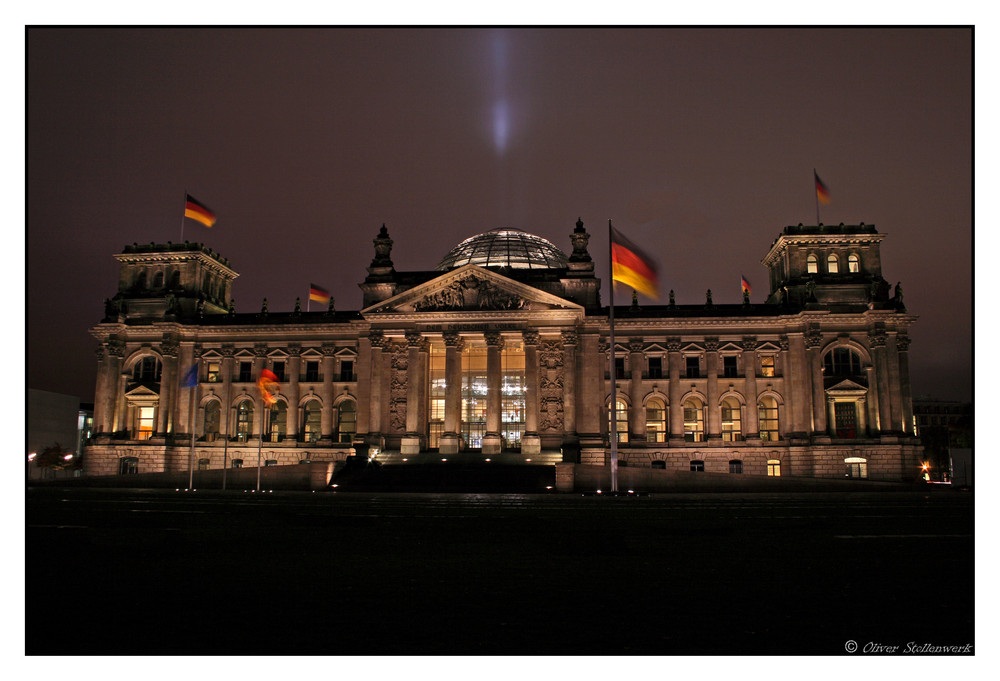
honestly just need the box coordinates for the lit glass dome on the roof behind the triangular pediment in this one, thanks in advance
[434,227,568,270]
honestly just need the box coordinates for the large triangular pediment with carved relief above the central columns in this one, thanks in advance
[361,264,583,315]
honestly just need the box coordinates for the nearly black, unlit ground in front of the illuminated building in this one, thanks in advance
[25,488,975,655]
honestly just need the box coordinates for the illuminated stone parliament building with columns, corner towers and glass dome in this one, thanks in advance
[85,222,921,480]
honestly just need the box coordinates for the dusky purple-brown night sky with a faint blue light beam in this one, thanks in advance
[25,28,973,402]
